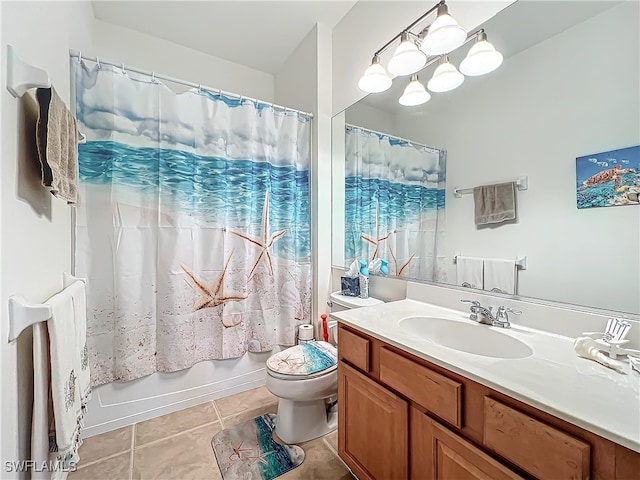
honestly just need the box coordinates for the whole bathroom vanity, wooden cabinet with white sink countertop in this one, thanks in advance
[332,292,640,480]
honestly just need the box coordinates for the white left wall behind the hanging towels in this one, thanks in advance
[0,2,93,472]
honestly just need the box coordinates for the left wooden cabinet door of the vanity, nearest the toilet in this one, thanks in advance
[338,362,409,480]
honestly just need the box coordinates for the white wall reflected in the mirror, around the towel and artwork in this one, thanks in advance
[398,2,640,313]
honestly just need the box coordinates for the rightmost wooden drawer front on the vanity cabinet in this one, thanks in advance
[483,397,591,480]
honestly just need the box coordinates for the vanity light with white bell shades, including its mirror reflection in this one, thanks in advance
[358,0,502,105]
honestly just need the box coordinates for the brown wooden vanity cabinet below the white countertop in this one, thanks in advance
[338,324,640,480]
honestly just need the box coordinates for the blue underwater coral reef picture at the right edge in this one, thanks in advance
[576,145,640,208]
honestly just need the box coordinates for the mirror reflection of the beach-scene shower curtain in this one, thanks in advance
[345,125,446,282]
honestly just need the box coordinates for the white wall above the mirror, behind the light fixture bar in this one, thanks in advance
[332,0,514,115]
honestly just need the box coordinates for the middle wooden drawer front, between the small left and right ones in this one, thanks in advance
[380,347,462,428]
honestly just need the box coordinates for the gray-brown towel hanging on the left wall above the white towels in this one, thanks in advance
[36,87,78,204]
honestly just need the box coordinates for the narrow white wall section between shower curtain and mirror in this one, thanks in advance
[276,24,331,337]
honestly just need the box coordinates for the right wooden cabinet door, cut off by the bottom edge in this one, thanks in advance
[411,408,523,480]
